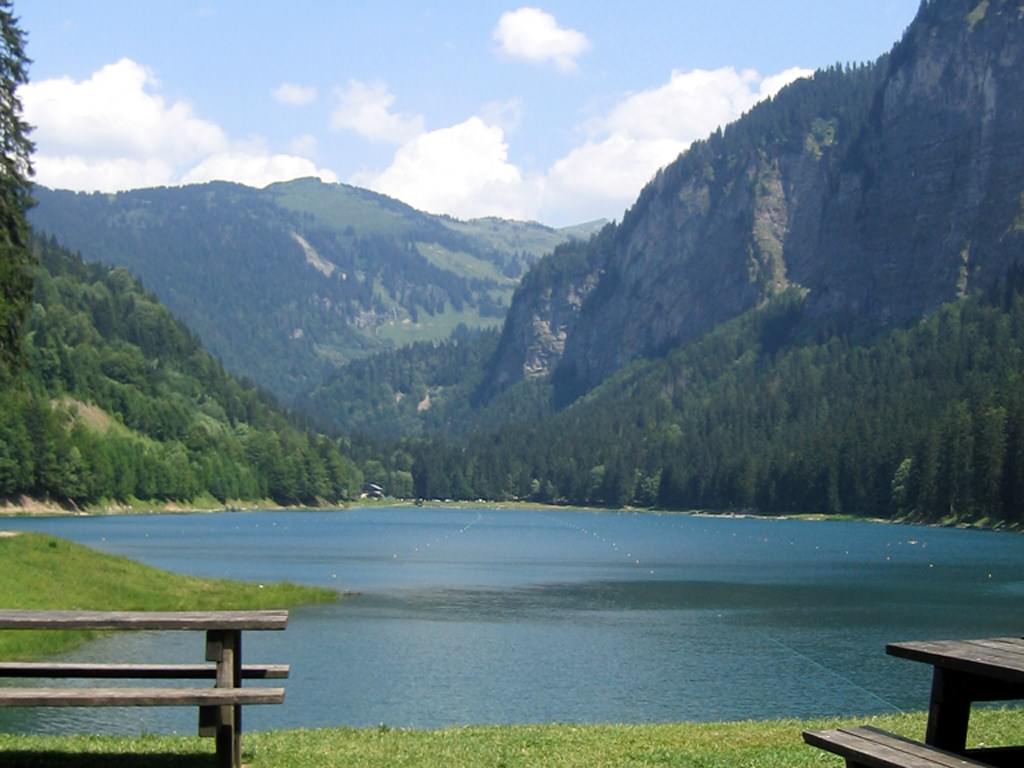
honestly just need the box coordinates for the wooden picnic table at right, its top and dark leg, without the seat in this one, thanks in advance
[886,637,1024,766]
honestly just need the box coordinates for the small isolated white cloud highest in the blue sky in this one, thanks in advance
[494,7,590,72]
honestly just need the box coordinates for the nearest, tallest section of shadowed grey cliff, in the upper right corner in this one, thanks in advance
[786,0,1024,323]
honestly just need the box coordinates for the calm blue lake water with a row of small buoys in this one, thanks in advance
[0,508,1024,733]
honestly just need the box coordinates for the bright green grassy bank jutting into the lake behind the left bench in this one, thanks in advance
[0,534,338,659]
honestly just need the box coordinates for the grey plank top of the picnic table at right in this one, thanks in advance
[886,638,1024,684]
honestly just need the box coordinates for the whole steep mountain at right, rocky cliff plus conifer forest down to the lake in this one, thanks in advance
[309,0,1024,527]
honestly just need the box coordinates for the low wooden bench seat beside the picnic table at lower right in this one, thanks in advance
[804,725,993,768]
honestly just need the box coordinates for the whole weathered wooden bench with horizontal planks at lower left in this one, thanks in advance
[0,610,289,768]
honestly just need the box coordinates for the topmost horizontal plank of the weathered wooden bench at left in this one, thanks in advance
[0,610,288,630]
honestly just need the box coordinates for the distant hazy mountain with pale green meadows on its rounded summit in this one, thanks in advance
[30,179,602,400]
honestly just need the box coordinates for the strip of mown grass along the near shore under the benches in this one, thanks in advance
[0,710,1024,768]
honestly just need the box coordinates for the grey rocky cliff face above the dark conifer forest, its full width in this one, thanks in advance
[487,0,1024,403]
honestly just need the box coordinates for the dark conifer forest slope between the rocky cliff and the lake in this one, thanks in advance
[397,280,1024,525]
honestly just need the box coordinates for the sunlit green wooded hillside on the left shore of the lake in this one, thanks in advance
[0,239,362,512]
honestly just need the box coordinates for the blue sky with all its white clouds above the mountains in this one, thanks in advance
[22,0,919,225]
